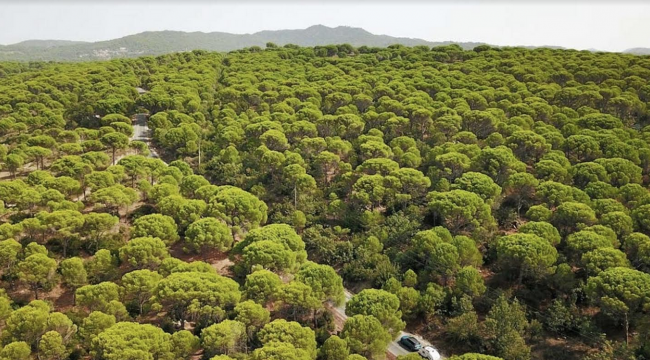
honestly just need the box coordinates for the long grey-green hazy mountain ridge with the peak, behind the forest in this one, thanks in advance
[0,25,483,61]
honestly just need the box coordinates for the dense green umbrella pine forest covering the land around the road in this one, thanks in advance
[0,44,650,360]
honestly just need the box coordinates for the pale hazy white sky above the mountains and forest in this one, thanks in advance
[0,0,650,51]
